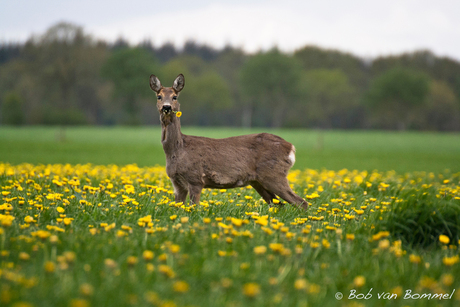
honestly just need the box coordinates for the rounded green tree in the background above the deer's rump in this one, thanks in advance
[240,49,301,127]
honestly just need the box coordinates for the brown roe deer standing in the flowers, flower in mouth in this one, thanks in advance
[150,74,308,210]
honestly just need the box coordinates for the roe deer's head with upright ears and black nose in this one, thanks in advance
[150,74,185,118]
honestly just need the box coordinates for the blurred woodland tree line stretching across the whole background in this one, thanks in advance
[0,23,460,131]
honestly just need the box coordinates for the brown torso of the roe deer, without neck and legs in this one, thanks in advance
[167,133,293,188]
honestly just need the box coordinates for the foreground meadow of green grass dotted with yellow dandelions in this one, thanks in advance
[0,163,460,306]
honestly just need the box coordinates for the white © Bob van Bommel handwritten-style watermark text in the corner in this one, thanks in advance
[335,288,455,300]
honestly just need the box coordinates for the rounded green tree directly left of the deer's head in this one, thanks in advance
[101,48,158,124]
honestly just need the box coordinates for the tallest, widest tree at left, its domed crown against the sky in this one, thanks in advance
[0,23,107,125]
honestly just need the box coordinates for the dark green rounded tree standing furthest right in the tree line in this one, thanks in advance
[365,68,429,130]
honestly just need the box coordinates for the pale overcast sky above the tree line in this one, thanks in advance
[0,0,460,60]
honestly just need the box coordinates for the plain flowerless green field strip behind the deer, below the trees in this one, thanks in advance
[0,127,460,172]
